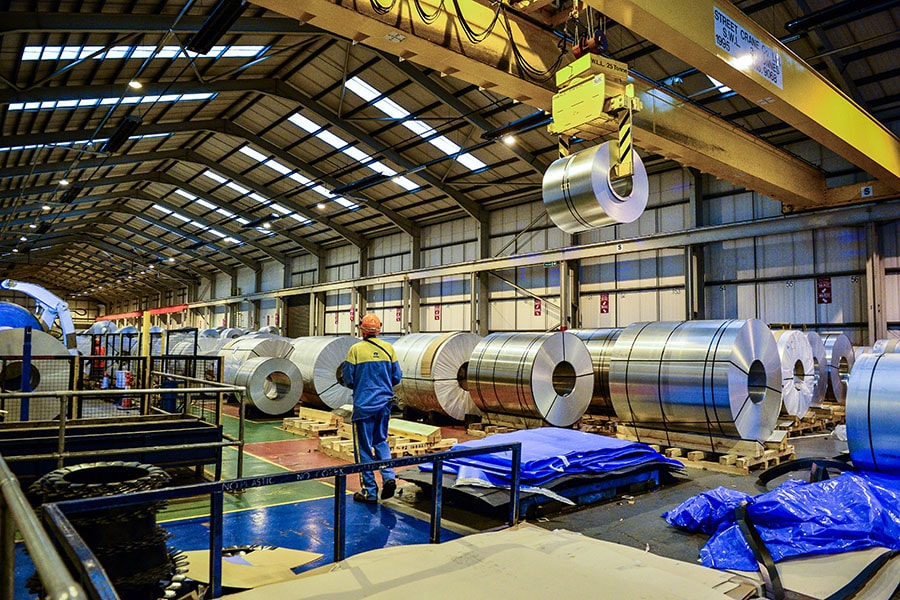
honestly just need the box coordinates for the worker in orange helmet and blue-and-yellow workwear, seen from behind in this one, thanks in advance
[343,313,402,503]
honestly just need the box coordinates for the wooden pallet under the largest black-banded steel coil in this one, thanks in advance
[617,425,796,475]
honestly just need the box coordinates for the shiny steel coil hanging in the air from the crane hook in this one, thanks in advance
[542,142,650,233]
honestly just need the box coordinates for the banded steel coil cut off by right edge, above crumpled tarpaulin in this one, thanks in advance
[847,353,900,475]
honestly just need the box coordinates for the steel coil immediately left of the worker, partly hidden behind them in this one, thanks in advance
[290,335,359,409]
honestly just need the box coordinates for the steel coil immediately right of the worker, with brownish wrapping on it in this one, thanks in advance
[394,333,481,421]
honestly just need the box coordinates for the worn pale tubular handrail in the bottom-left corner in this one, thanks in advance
[0,456,87,600]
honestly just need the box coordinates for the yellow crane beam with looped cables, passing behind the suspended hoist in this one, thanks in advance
[252,0,836,206]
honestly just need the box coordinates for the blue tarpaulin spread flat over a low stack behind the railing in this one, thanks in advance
[420,427,683,487]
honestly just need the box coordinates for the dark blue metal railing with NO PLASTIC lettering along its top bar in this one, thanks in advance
[42,442,522,600]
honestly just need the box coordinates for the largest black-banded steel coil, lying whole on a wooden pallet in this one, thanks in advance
[609,319,781,441]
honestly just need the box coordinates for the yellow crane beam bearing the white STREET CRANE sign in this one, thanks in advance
[587,0,900,190]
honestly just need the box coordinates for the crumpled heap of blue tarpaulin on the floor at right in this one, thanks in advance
[663,472,900,571]
